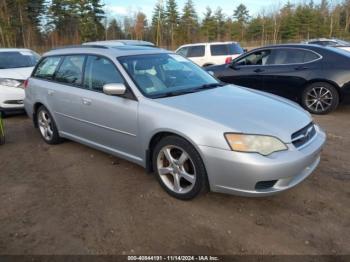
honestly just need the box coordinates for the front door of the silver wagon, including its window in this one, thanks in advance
[79,55,140,160]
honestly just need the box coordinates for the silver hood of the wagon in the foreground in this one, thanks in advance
[155,85,312,143]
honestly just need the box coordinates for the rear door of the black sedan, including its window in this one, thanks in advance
[261,48,321,100]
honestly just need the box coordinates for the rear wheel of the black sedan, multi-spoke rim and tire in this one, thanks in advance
[301,82,339,115]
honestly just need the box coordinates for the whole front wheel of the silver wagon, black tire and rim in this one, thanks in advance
[152,136,207,200]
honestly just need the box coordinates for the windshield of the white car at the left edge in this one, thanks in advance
[0,51,40,69]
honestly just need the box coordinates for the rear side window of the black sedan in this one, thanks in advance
[267,48,320,65]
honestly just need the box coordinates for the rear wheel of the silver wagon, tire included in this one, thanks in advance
[36,106,62,145]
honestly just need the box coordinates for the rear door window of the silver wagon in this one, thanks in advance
[55,55,85,86]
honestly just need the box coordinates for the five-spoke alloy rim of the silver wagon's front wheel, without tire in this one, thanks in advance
[157,146,196,194]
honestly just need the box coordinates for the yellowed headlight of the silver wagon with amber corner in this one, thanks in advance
[225,134,288,156]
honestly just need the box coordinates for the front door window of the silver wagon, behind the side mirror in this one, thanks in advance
[84,56,124,92]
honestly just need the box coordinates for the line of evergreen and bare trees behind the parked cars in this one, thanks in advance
[0,0,350,50]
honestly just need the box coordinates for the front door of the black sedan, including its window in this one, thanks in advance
[220,50,271,89]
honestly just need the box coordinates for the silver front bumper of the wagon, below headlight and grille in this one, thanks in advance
[200,127,326,197]
